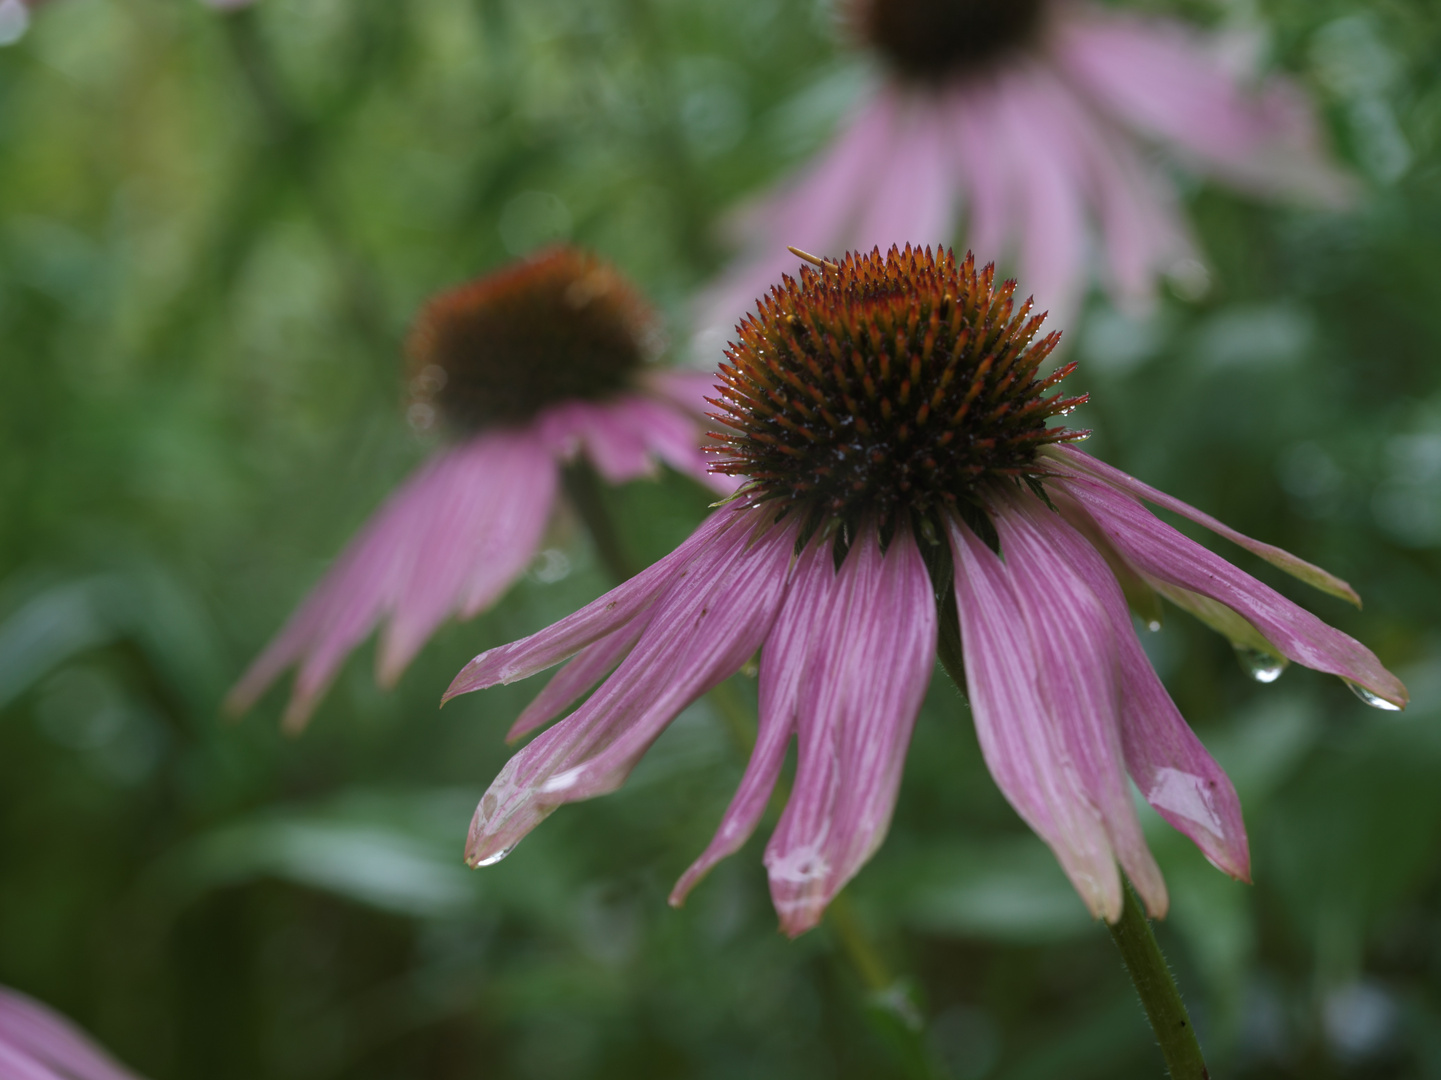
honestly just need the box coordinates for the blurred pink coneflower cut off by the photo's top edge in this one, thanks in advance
[700,0,1353,335]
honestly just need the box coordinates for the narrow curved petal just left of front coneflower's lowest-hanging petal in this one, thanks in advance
[670,542,836,907]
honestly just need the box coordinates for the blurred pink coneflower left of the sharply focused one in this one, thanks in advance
[226,248,731,730]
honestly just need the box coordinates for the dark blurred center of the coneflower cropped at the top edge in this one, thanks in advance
[852,0,1045,81]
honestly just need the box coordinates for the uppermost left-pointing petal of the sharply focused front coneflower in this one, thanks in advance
[441,505,755,704]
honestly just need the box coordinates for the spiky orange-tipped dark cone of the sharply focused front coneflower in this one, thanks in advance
[713,245,1085,528]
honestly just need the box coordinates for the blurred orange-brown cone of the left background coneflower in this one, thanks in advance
[408,247,654,431]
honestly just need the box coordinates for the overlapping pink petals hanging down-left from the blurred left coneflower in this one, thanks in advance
[226,431,556,730]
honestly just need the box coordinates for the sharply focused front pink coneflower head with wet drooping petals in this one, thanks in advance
[447,248,1406,934]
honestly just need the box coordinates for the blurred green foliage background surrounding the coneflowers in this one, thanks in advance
[0,0,1441,1080]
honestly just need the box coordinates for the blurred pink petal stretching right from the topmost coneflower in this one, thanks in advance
[1053,10,1355,206]
